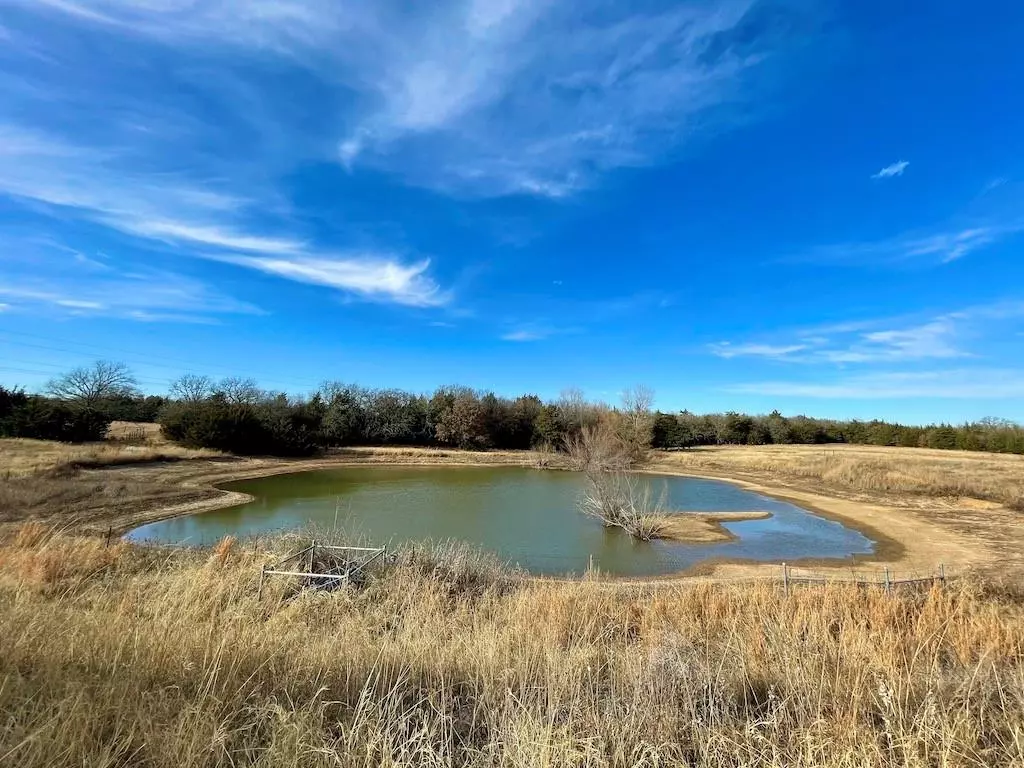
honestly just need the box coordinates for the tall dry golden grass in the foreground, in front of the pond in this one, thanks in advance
[0,524,1024,768]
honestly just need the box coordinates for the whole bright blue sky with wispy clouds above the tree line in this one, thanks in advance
[0,0,1024,422]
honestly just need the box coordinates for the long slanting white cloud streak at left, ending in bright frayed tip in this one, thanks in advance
[0,125,450,306]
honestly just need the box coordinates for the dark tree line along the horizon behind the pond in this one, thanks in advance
[0,361,1024,456]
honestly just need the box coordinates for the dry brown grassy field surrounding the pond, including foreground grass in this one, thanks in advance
[0,434,1024,768]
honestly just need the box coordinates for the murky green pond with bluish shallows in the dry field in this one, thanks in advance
[129,467,873,577]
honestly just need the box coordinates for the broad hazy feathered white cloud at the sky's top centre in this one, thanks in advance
[331,0,802,198]
